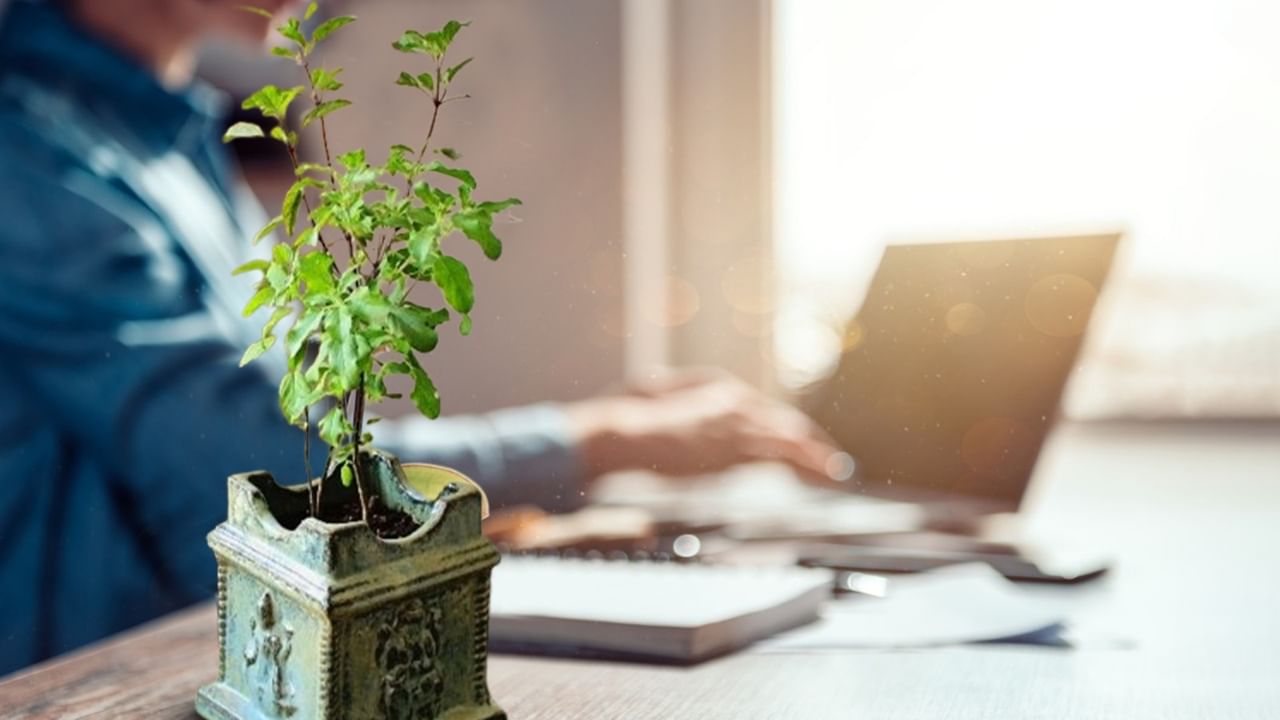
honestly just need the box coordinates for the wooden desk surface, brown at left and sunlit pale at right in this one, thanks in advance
[0,424,1280,720]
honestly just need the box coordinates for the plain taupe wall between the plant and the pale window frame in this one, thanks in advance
[325,0,622,413]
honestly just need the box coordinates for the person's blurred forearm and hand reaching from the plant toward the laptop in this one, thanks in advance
[374,369,847,511]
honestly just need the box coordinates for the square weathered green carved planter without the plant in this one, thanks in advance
[196,454,506,720]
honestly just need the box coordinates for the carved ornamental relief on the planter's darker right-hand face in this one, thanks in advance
[376,598,444,720]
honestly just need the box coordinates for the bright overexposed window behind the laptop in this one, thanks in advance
[774,0,1280,415]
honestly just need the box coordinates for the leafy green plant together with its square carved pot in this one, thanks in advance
[196,4,518,720]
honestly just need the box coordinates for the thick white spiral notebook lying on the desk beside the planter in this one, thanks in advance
[489,557,832,662]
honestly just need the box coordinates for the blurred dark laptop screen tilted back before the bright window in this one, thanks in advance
[805,233,1120,510]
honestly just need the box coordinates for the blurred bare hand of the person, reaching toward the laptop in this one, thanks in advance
[568,370,842,486]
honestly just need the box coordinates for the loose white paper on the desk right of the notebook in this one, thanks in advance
[756,562,1065,652]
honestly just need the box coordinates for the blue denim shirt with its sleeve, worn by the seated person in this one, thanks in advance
[0,0,581,674]
